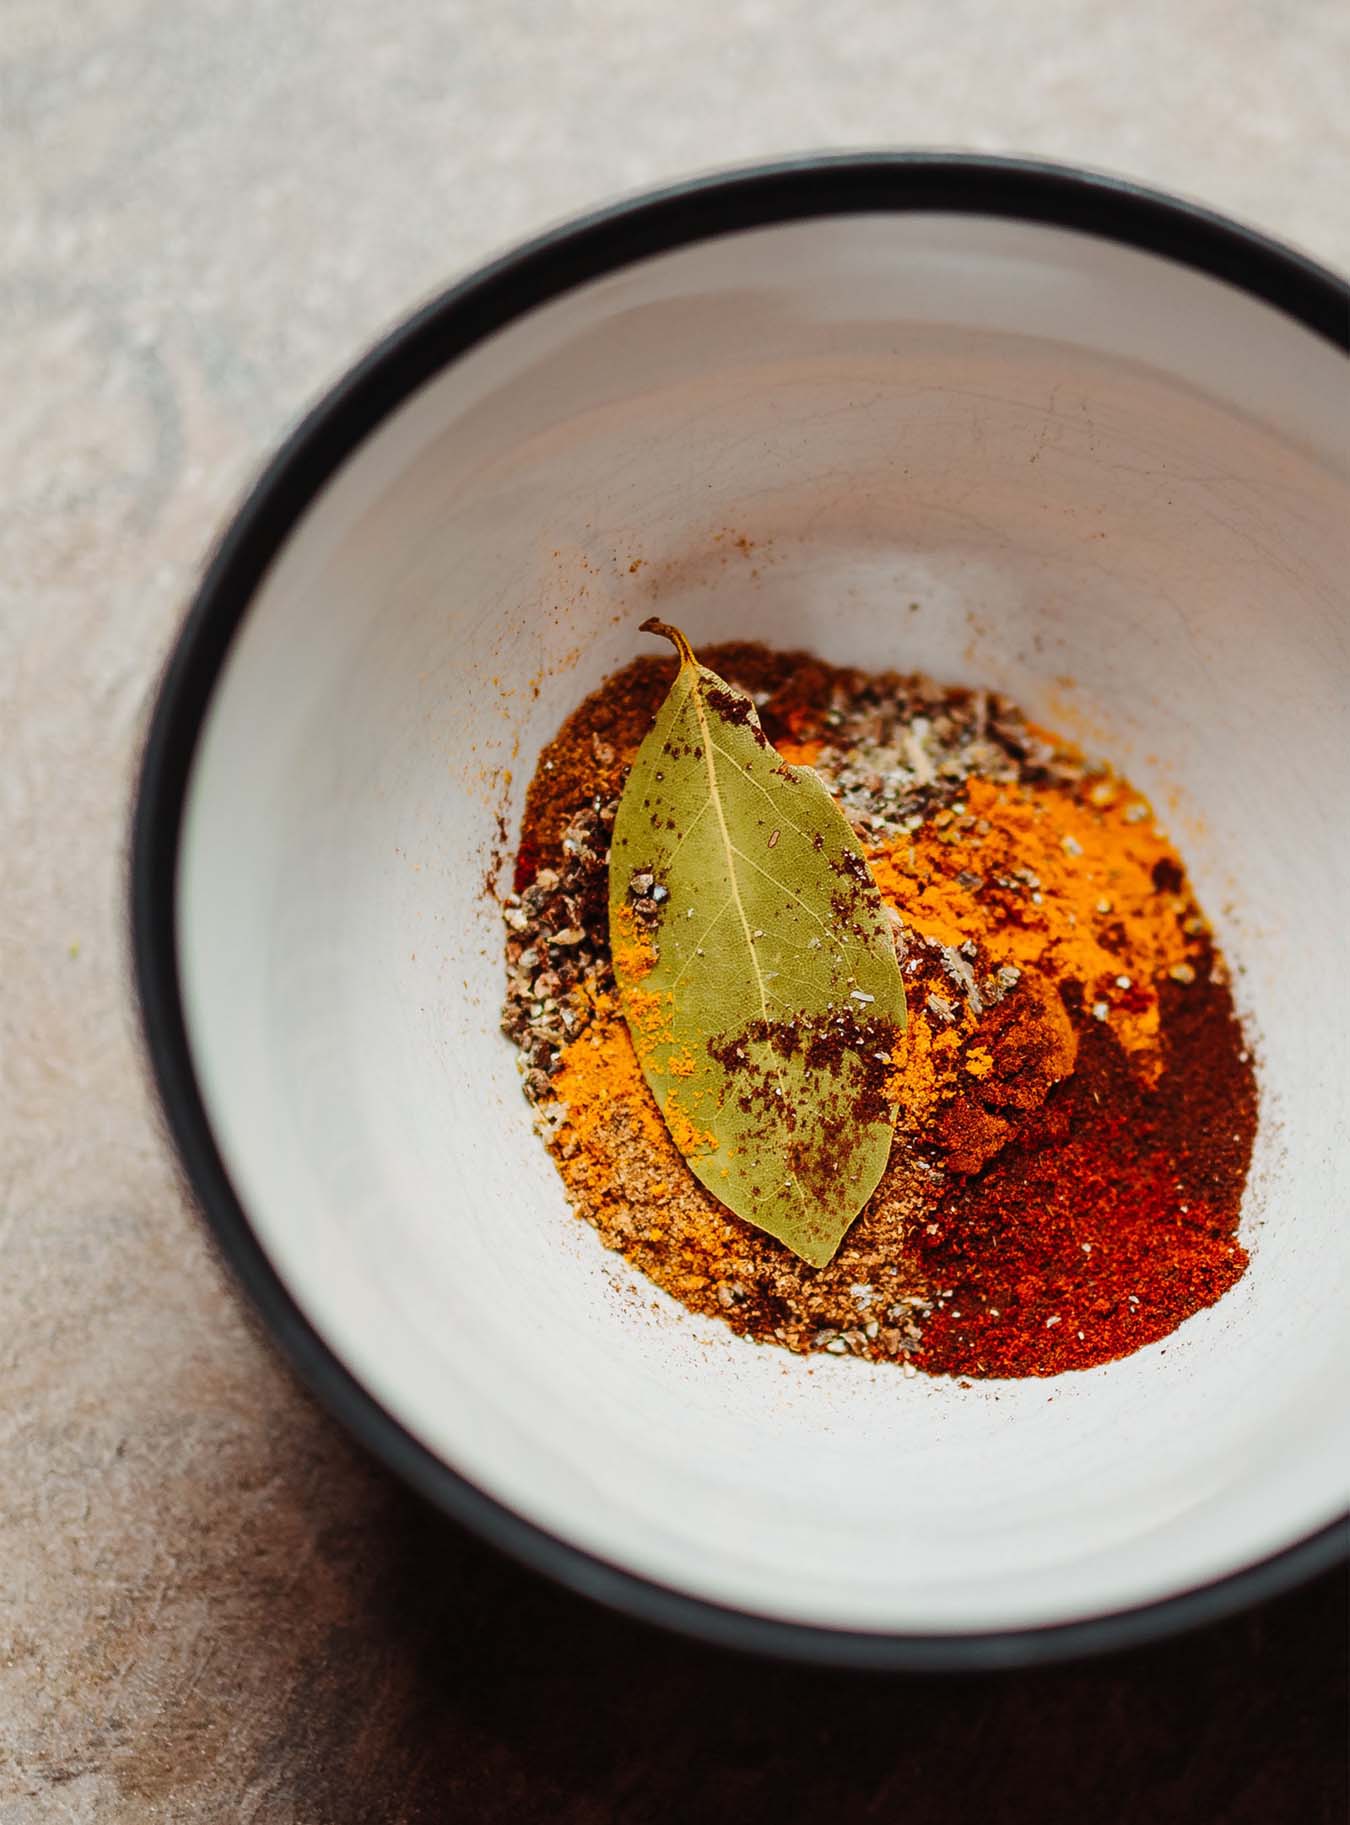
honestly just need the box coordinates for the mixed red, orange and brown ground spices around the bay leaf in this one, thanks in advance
[502,644,1257,1376]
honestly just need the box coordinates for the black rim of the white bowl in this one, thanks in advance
[130,151,1350,1672]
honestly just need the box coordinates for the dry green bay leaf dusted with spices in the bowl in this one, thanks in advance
[609,621,905,1267]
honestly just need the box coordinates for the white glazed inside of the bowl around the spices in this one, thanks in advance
[179,215,1350,1633]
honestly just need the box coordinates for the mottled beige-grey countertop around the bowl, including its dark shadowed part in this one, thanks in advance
[0,0,1350,1825]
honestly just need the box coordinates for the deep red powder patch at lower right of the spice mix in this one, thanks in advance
[916,960,1257,1376]
